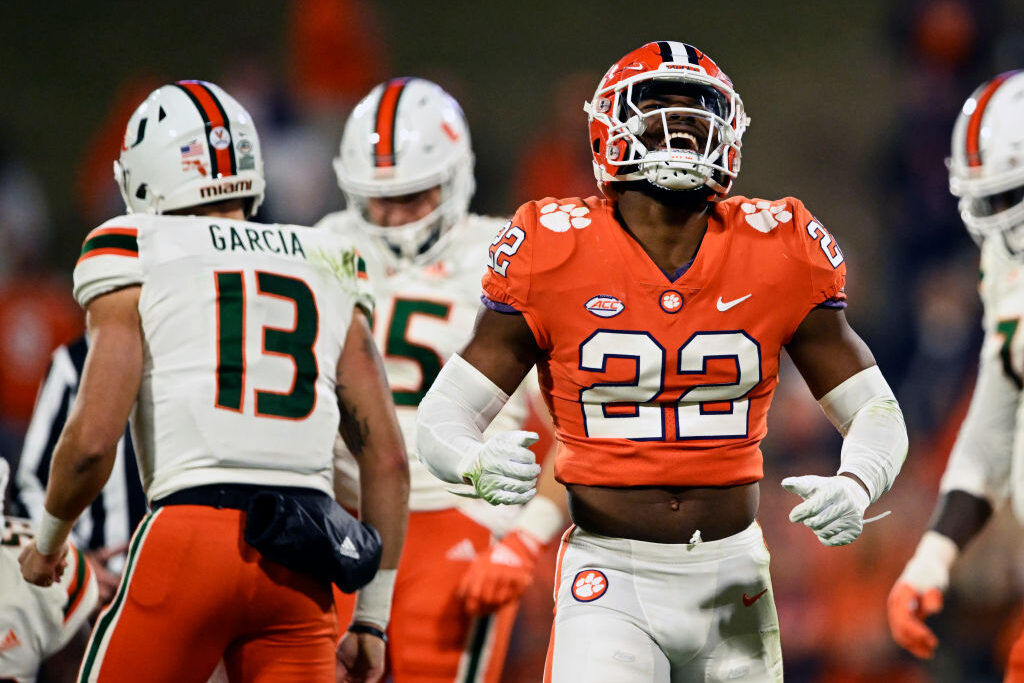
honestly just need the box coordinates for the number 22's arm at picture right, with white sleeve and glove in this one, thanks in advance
[782,308,907,546]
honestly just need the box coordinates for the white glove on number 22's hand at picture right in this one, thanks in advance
[782,474,871,546]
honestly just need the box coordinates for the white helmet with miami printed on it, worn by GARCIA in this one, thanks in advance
[114,81,266,216]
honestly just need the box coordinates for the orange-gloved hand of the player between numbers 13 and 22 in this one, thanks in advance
[459,529,541,614]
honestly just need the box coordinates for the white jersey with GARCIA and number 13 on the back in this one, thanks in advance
[75,214,372,502]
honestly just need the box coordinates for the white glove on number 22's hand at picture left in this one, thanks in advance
[459,430,541,505]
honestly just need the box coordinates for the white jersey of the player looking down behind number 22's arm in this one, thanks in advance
[316,211,536,520]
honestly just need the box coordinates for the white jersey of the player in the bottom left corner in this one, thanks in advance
[0,517,97,683]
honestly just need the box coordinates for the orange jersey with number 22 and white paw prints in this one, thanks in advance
[483,197,846,486]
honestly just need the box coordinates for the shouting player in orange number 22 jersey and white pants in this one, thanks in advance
[417,41,907,683]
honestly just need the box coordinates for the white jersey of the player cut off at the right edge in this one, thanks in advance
[940,238,1024,521]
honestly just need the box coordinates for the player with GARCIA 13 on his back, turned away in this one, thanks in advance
[22,81,409,683]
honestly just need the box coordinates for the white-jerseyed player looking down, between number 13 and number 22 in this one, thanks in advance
[317,78,566,683]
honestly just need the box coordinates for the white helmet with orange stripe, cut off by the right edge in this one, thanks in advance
[946,71,1024,252]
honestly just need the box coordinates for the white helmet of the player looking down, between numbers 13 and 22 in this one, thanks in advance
[334,78,475,263]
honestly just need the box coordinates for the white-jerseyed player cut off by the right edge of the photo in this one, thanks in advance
[888,71,1024,683]
